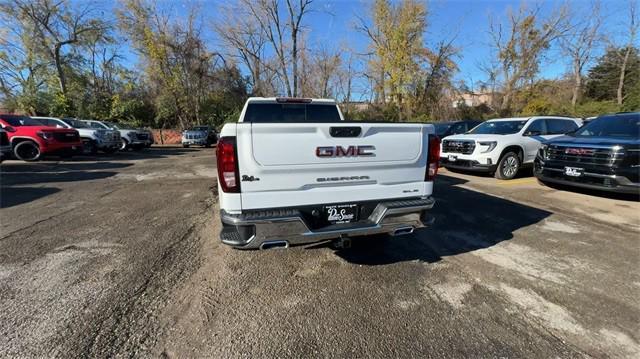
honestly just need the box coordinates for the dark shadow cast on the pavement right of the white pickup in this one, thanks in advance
[335,175,552,265]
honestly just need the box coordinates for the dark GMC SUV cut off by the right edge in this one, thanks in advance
[533,112,640,194]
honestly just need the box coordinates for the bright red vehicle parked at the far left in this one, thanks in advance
[0,114,82,161]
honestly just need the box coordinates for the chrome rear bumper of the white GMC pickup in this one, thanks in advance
[220,197,435,249]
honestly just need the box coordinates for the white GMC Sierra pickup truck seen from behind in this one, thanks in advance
[216,98,440,249]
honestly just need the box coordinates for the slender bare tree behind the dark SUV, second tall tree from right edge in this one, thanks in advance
[560,1,602,109]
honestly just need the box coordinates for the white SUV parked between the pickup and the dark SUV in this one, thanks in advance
[440,116,582,179]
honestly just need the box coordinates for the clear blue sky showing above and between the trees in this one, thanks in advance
[95,0,629,100]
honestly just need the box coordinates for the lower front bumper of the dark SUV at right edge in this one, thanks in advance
[533,159,640,194]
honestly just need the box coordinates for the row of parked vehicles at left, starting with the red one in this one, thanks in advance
[0,114,153,161]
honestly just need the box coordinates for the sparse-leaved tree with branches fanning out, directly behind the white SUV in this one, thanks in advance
[489,4,568,113]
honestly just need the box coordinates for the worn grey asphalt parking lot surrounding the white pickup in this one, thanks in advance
[0,147,640,358]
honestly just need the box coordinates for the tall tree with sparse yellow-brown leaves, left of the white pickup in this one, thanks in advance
[118,0,224,128]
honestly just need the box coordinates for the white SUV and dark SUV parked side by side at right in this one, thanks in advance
[440,112,640,193]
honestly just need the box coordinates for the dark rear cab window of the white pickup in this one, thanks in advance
[243,103,341,123]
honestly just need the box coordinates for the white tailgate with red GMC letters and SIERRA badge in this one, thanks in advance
[236,123,433,209]
